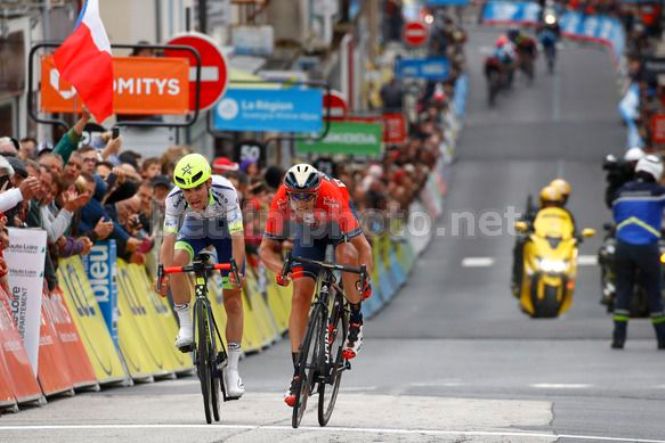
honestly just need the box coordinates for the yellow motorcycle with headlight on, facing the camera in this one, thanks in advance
[515,207,596,318]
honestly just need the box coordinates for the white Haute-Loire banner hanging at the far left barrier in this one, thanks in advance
[5,228,46,376]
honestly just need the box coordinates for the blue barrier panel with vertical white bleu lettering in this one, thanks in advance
[83,240,118,347]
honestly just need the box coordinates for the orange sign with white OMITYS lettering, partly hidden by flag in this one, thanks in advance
[40,56,189,115]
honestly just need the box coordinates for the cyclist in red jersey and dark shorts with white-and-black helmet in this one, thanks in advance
[259,164,373,407]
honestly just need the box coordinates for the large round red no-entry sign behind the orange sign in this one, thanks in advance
[164,32,229,111]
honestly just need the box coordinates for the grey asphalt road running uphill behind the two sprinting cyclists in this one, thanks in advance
[0,26,665,443]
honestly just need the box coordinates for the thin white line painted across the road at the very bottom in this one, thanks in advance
[0,424,665,443]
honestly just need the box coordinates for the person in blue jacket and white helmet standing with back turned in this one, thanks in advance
[611,155,665,350]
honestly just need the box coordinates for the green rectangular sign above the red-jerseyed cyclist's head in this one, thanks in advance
[296,121,383,156]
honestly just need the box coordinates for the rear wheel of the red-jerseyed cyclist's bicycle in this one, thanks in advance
[319,294,349,426]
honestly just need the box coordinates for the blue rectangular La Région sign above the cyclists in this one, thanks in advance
[213,88,323,132]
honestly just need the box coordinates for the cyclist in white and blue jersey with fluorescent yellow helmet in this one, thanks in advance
[160,154,245,397]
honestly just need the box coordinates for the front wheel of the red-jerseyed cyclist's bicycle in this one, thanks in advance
[291,304,325,428]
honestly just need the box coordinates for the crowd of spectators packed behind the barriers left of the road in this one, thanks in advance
[0,6,466,289]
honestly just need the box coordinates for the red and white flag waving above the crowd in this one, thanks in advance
[53,0,113,123]
